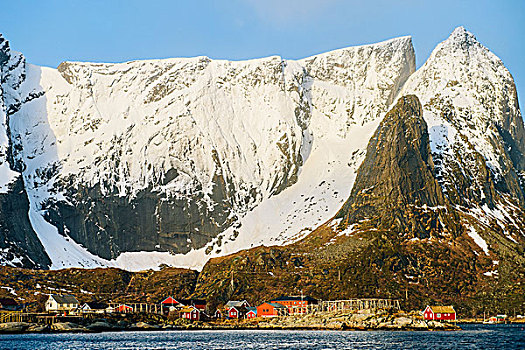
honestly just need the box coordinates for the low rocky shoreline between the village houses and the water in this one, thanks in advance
[0,313,460,334]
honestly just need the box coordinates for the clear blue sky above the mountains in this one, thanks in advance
[0,0,525,112]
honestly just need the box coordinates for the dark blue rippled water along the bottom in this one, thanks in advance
[0,325,525,350]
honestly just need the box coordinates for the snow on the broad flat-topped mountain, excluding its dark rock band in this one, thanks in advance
[11,37,415,269]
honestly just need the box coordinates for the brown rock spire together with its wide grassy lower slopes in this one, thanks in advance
[196,95,525,315]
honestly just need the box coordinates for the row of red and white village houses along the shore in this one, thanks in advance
[0,294,474,323]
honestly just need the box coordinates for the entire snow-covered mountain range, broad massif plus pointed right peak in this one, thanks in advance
[0,28,525,270]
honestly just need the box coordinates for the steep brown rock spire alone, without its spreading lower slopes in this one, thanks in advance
[336,95,459,238]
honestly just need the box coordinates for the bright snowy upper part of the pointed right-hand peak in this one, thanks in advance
[402,27,523,179]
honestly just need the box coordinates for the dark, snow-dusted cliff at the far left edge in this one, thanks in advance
[0,35,50,268]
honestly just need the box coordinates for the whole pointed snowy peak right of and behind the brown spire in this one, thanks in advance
[400,27,525,240]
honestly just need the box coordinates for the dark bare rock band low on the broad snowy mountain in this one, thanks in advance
[45,178,233,259]
